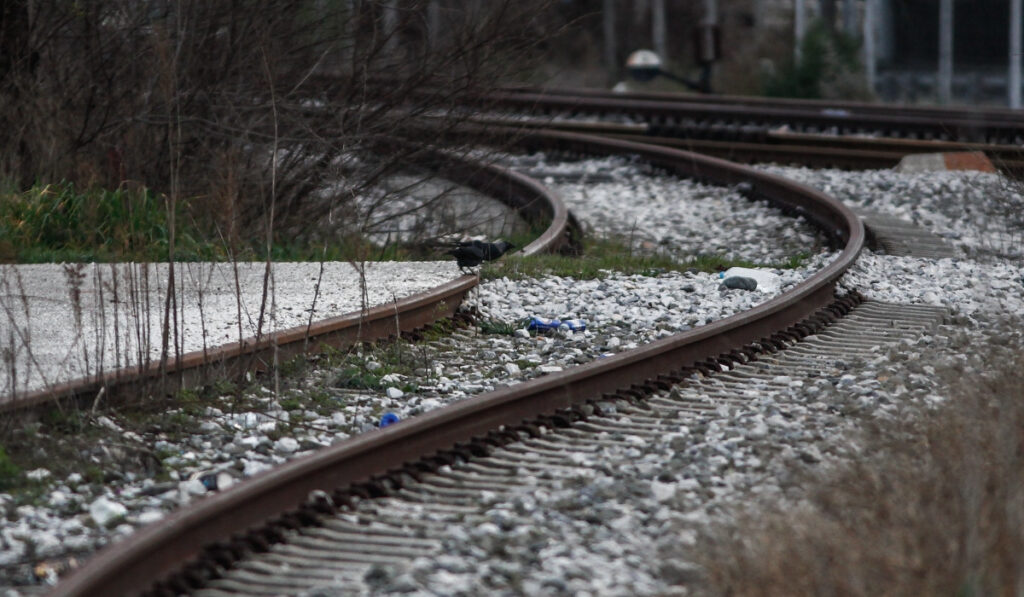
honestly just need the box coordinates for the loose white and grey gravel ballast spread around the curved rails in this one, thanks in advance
[0,158,1024,595]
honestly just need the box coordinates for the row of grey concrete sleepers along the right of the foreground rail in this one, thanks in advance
[196,300,946,597]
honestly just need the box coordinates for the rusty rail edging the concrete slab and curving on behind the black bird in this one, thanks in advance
[0,153,580,413]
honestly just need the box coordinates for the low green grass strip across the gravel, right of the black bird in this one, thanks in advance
[480,238,808,280]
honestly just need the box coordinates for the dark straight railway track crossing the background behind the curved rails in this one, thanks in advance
[468,88,1024,176]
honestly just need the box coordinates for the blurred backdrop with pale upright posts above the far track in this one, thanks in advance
[546,0,1022,108]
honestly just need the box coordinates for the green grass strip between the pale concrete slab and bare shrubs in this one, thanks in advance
[0,181,524,263]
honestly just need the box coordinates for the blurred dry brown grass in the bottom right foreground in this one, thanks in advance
[698,346,1024,596]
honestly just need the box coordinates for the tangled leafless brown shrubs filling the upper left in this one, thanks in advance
[0,0,548,249]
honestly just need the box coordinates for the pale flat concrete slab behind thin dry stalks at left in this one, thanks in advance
[0,261,461,400]
